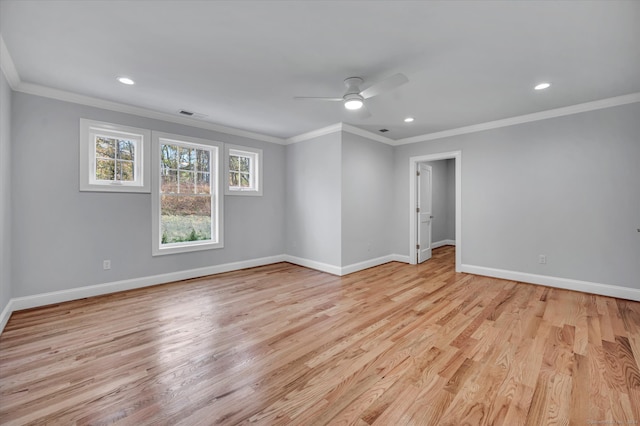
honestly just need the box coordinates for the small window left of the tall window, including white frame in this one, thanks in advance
[80,118,151,192]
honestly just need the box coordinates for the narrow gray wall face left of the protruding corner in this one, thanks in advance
[286,132,342,266]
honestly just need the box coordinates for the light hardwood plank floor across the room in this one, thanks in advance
[0,247,640,426]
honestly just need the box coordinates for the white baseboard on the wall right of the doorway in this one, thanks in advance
[461,265,640,302]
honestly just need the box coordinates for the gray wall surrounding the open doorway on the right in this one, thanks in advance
[392,103,640,288]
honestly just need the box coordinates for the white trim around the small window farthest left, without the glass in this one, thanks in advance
[80,118,151,193]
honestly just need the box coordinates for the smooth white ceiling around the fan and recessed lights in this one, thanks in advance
[0,0,640,139]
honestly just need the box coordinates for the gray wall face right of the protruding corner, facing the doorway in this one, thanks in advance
[342,132,394,266]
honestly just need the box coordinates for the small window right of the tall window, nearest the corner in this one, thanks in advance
[225,145,262,195]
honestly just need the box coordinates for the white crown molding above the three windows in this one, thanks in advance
[13,83,284,145]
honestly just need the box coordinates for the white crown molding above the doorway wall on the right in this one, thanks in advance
[393,92,640,146]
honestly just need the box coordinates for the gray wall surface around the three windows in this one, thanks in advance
[11,92,285,297]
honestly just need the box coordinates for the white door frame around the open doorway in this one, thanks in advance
[409,151,462,272]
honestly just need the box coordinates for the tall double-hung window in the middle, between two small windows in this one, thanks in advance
[152,132,223,256]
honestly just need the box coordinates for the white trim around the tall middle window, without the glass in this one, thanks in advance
[151,131,224,256]
